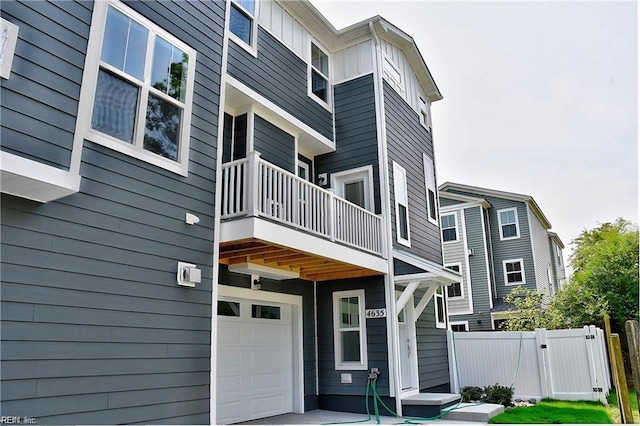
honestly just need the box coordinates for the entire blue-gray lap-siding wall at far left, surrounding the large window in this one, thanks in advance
[0,1,225,424]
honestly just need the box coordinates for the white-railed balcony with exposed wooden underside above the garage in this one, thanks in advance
[220,152,387,281]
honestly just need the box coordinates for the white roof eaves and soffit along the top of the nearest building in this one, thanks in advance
[283,0,442,102]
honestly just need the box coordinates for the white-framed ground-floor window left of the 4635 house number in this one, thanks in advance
[333,290,367,370]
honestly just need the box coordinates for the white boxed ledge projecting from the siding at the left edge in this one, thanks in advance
[0,152,81,203]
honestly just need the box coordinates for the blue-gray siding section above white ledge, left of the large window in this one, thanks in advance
[0,1,92,170]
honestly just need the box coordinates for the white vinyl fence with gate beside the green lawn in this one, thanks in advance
[448,326,611,403]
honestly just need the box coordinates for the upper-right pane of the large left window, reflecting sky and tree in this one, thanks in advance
[151,37,189,102]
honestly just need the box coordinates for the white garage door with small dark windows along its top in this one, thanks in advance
[216,298,293,424]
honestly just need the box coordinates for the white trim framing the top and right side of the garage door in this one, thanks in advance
[218,284,304,413]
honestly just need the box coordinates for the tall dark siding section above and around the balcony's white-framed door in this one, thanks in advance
[315,74,381,214]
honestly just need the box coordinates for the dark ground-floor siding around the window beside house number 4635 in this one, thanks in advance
[317,277,389,398]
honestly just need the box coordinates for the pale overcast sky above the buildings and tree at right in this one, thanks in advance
[312,0,639,268]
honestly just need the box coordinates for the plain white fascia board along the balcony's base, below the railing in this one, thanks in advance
[220,217,388,274]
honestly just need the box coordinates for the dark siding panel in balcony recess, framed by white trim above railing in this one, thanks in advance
[253,114,296,173]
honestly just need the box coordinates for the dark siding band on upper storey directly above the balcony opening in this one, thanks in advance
[227,26,333,140]
